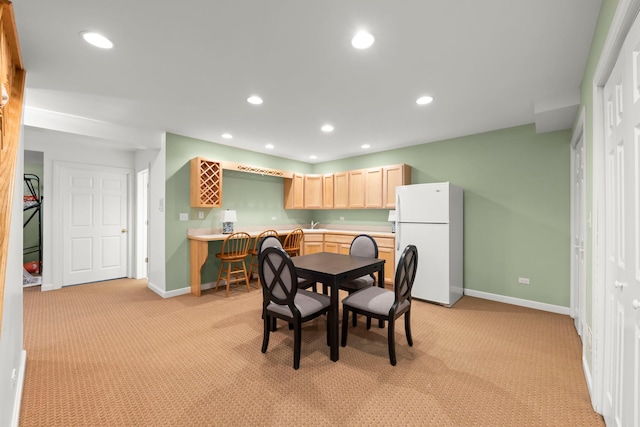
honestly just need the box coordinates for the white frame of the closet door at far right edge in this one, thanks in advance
[584,0,640,413]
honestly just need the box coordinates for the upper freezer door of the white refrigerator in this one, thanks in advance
[396,182,449,223]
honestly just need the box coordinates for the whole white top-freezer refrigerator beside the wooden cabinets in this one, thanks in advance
[396,182,463,307]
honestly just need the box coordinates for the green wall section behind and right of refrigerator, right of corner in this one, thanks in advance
[314,125,571,307]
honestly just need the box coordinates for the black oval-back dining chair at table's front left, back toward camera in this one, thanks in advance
[258,247,332,369]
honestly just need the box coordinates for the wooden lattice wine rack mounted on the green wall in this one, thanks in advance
[191,157,222,208]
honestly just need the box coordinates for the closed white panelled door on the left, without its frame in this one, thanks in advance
[61,166,128,286]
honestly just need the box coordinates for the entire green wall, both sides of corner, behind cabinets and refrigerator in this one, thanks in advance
[166,125,571,307]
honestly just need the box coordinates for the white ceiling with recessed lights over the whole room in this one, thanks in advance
[14,0,601,163]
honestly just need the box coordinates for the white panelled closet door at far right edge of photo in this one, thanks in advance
[603,9,640,426]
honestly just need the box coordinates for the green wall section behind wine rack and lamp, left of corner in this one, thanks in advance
[165,134,311,291]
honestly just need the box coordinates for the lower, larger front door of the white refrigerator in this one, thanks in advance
[396,223,455,305]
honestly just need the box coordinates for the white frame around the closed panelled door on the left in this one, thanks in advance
[51,160,135,289]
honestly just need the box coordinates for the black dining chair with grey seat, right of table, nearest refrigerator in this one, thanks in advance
[341,245,418,366]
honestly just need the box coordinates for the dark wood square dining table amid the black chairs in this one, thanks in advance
[291,252,385,362]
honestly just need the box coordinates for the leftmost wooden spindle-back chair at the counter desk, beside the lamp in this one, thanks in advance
[215,231,251,296]
